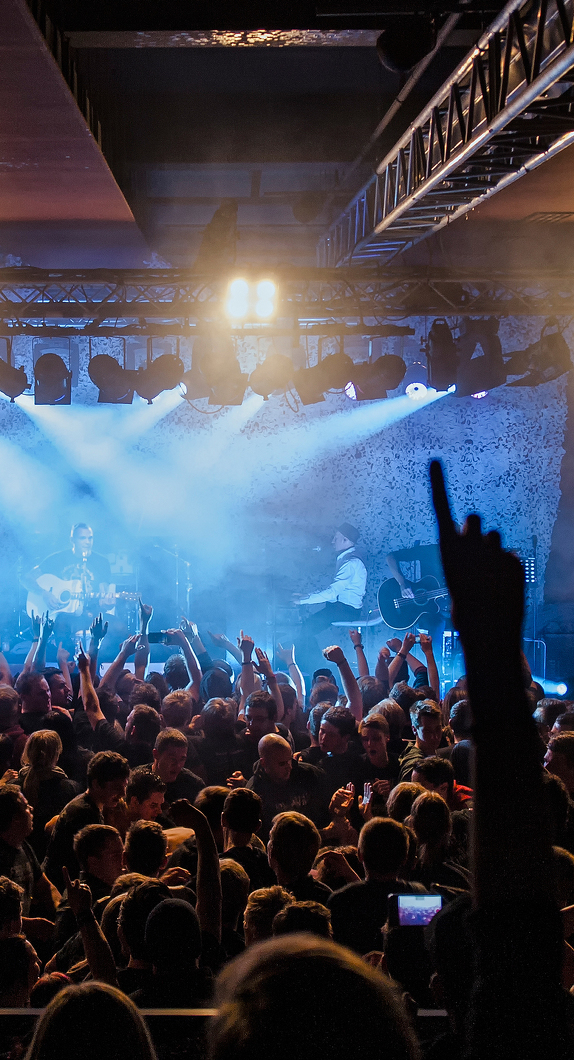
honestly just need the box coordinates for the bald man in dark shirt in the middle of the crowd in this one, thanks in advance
[246,732,328,843]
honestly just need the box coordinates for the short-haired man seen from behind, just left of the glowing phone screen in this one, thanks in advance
[327,817,425,954]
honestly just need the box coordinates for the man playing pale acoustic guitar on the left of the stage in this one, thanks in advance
[22,523,115,641]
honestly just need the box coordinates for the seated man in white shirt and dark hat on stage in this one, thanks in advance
[295,523,366,669]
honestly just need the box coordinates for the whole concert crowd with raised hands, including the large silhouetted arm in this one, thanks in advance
[0,464,574,1060]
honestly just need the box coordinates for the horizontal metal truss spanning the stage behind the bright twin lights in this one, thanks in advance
[0,266,574,330]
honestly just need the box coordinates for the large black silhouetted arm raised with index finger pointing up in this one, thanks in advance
[430,461,566,1060]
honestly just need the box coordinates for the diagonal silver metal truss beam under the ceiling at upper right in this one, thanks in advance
[318,0,574,267]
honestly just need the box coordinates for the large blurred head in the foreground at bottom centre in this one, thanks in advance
[210,935,418,1060]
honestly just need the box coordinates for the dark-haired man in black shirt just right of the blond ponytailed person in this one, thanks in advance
[43,750,129,890]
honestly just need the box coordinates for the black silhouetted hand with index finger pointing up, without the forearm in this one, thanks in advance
[430,460,524,656]
